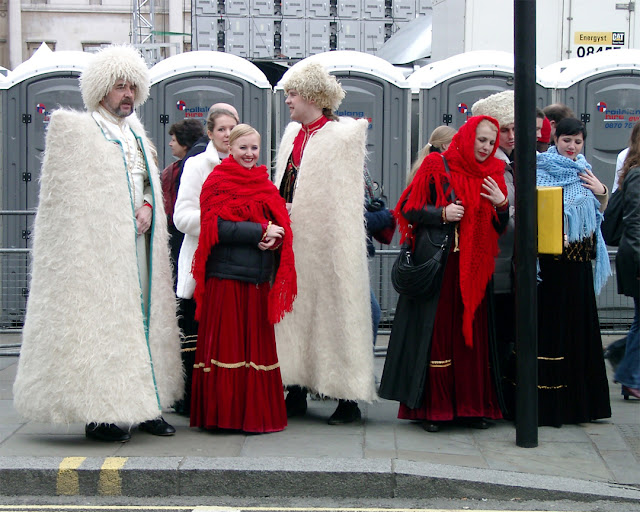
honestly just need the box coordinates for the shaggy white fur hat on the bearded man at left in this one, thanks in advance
[80,45,149,111]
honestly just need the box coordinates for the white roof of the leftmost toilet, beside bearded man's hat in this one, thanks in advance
[0,43,91,88]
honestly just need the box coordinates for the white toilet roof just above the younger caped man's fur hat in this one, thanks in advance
[275,50,409,89]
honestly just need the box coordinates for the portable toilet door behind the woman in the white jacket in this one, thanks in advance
[158,76,242,169]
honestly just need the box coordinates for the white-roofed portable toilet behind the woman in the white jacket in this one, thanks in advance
[140,51,271,172]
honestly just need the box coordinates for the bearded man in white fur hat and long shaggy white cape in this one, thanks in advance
[14,46,183,442]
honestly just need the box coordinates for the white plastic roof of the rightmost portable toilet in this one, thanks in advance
[543,49,640,89]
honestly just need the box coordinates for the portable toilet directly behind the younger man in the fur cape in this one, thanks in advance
[274,51,410,321]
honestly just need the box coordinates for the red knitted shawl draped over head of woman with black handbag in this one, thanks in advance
[395,116,507,347]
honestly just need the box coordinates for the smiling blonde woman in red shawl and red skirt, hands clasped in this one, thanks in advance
[191,124,296,432]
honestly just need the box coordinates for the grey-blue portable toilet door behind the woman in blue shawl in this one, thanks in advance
[576,75,640,190]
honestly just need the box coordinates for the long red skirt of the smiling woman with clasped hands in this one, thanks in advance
[191,278,287,432]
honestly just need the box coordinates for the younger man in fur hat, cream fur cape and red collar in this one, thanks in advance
[276,63,376,425]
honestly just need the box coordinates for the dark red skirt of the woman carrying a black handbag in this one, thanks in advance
[398,252,502,421]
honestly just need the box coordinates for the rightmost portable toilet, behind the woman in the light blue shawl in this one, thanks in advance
[544,50,640,190]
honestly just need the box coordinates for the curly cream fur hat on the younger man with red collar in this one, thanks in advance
[282,62,345,111]
